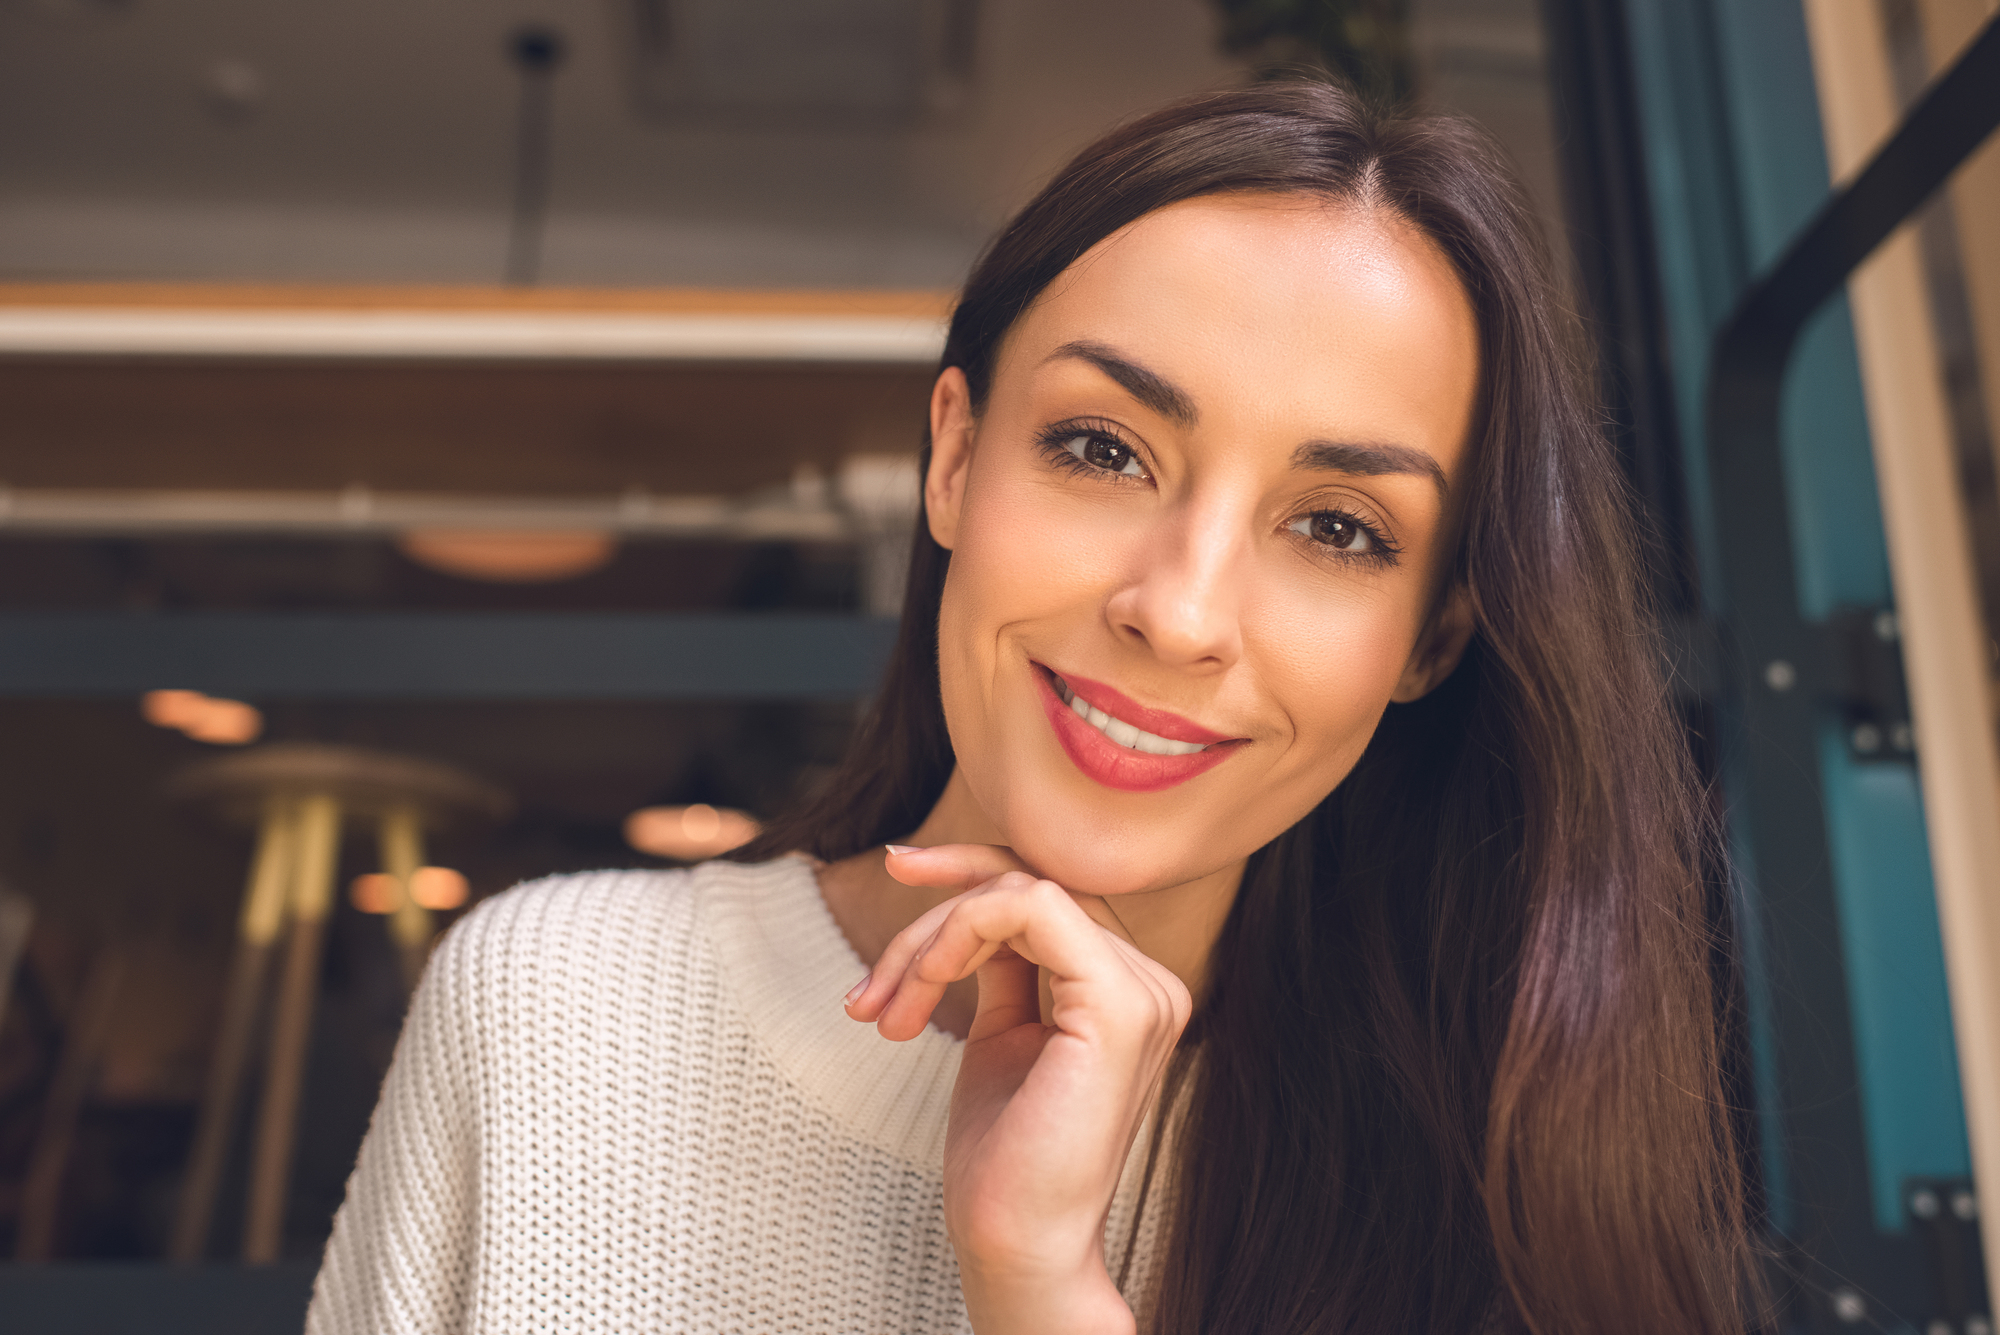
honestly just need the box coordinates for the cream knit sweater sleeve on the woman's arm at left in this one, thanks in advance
[306,913,484,1335]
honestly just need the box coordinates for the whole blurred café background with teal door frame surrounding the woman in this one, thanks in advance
[0,0,2000,1335]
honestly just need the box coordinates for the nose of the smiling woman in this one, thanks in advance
[1106,497,1250,671]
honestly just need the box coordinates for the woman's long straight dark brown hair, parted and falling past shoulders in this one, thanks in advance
[740,84,1750,1335]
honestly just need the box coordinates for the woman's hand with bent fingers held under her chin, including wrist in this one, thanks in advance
[848,843,1192,1335]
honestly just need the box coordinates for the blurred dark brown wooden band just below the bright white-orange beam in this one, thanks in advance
[0,358,932,500]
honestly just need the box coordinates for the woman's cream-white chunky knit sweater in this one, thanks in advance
[306,857,1160,1335]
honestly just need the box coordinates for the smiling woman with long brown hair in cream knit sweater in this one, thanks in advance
[312,84,1748,1335]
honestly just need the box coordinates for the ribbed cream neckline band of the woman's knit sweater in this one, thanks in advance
[694,853,964,1171]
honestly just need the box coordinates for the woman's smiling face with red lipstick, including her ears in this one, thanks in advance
[926,196,1480,893]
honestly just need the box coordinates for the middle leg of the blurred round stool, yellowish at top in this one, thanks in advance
[244,793,340,1265]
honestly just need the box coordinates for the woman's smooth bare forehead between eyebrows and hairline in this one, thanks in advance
[996,196,1480,485]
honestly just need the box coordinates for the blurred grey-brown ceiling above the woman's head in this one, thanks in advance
[0,0,1560,288]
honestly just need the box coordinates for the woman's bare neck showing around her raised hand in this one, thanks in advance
[820,769,1244,1037]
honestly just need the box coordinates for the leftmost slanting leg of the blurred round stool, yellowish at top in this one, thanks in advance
[168,797,298,1263]
